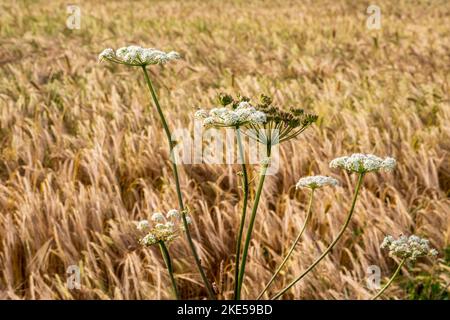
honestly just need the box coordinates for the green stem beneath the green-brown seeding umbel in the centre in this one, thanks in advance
[235,147,270,300]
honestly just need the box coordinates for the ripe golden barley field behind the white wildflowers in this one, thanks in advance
[0,0,450,299]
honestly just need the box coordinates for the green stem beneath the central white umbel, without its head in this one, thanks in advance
[234,127,249,299]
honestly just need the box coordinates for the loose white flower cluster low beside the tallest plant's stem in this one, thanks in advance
[136,209,191,246]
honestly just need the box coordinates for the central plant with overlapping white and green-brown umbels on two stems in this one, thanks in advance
[196,94,317,300]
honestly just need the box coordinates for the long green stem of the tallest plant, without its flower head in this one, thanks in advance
[142,66,215,299]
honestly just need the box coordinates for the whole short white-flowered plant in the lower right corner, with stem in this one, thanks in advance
[372,235,438,300]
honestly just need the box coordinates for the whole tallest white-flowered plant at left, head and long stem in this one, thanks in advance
[99,46,215,299]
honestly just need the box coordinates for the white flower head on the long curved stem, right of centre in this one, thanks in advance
[330,153,396,173]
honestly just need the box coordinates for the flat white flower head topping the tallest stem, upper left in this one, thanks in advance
[98,46,180,67]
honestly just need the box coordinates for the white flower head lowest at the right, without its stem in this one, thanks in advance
[381,235,438,261]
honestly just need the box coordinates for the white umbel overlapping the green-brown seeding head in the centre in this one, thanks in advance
[195,101,266,128]
